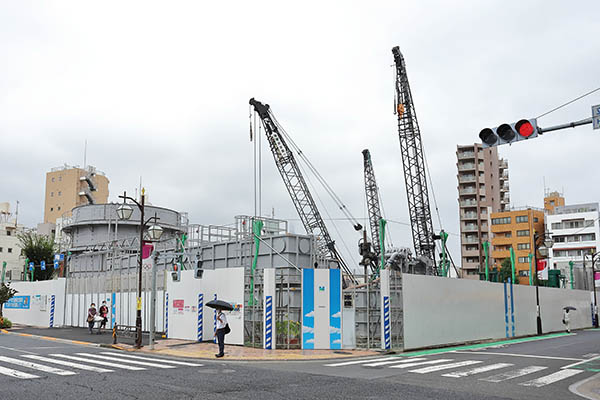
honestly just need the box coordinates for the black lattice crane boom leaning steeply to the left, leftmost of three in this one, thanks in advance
[250,98,362,283]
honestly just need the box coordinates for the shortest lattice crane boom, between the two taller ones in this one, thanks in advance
[359,149,381,272]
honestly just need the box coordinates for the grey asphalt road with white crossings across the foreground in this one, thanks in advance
[0,331,600,400]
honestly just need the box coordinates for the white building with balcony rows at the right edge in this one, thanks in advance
[547,203,600,289]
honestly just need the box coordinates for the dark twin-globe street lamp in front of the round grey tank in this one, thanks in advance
[117,189,163,349]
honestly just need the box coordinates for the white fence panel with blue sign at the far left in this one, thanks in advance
[3,278,65,327]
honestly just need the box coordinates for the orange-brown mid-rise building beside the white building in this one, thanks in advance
[489,207,544,284]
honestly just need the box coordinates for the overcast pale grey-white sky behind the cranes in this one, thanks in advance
[0,0,600,268]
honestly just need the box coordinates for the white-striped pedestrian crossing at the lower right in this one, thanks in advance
[324,356,584,388]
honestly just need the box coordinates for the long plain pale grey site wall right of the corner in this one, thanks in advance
[403,274,592,349]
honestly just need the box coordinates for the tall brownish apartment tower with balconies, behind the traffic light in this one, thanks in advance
[456,143,510,279]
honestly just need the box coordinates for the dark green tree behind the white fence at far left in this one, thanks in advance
[17,231,55,281]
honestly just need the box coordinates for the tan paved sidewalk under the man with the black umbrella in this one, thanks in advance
[2,325,381,361]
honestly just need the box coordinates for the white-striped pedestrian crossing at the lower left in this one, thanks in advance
[0,351,203,379]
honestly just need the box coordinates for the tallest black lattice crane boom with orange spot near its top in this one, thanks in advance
[392,46,437,275]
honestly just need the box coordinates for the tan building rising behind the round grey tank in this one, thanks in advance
[44,164,109,224]
